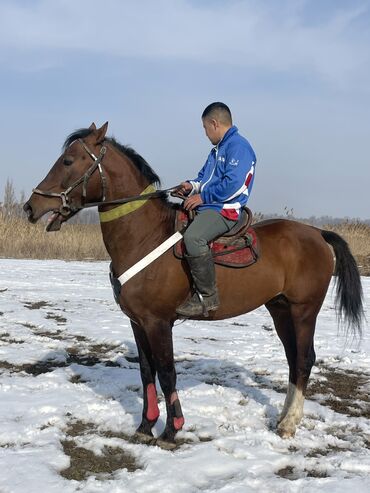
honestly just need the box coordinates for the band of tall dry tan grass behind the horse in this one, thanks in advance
[0,213,370,275]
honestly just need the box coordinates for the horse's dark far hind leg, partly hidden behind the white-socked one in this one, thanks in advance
[266,299,297,423]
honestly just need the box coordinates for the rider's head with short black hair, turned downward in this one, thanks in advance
[202,102,233,145]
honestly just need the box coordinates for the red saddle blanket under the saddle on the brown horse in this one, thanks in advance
[174,210,258,267]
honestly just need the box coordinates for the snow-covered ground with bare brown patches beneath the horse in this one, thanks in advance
[0,259,370,493]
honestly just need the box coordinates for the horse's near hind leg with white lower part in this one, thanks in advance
[278,303,321,438]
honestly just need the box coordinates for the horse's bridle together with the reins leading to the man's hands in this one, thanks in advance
[32,139,178,217]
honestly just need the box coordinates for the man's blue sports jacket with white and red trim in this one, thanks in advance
[189,126,256,220]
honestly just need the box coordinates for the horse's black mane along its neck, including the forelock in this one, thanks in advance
[63,128,161,186]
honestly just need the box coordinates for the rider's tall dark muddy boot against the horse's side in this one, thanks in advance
[176,251,220,318]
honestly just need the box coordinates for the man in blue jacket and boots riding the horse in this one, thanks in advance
[176,102,256,318]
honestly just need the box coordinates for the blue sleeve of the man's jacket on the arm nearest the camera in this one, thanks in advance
[201,146,255,204]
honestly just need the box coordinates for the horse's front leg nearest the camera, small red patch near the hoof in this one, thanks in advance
[147,321,184,448]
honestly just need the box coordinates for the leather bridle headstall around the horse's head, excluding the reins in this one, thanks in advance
[32,139,107,216]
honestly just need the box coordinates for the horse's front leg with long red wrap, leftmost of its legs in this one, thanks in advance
[131,322,159,440]
